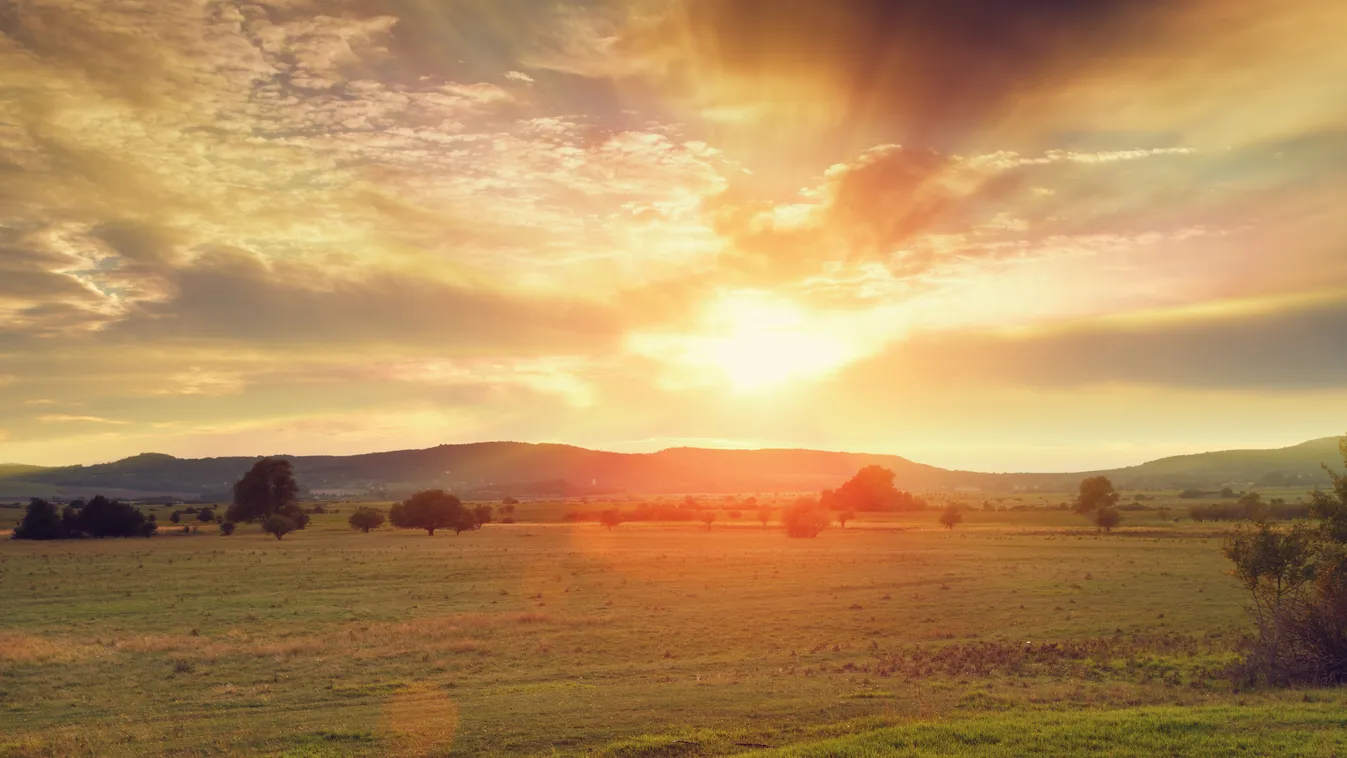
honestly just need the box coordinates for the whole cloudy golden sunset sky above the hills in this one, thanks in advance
[0,0,1347,471]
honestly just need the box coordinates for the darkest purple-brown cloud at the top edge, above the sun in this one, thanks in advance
[630,0,1177,147]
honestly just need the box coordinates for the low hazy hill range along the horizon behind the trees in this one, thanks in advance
[0,438,1340,499]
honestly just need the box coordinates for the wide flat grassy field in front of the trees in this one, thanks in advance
[0,505,1347,757]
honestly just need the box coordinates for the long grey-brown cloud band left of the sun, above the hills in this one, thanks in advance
[106,249,620,355]
